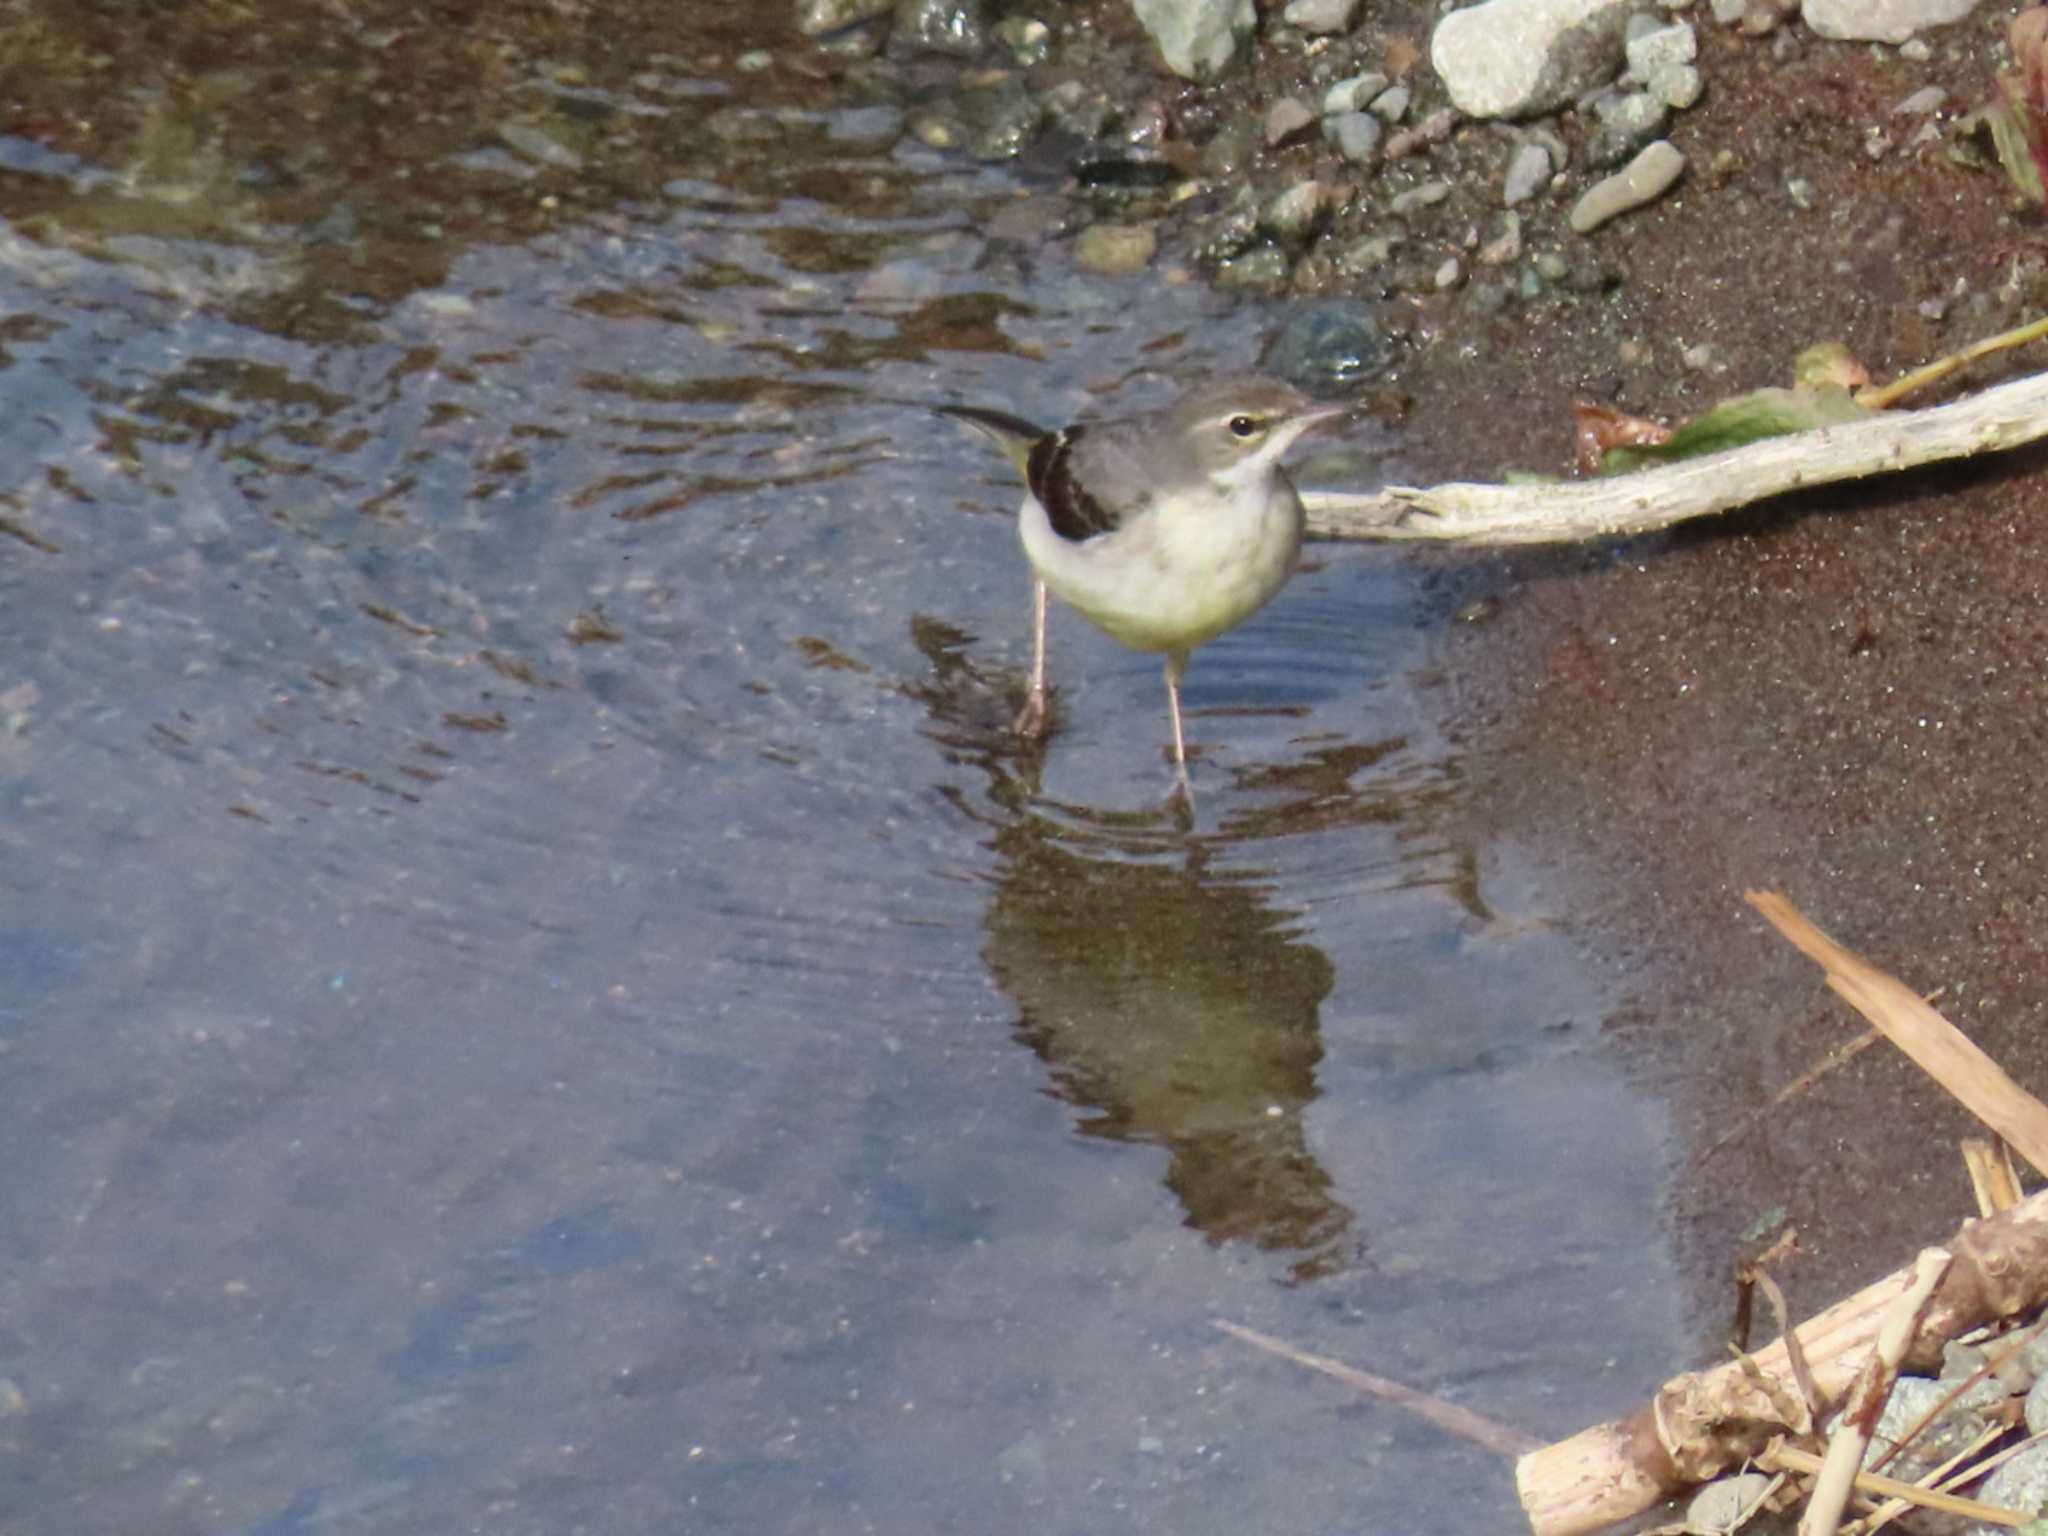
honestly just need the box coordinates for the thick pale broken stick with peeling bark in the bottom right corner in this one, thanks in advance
[1516,1190,2048,1536]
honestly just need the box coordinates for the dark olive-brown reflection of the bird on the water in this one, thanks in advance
[911,621,1358,1280]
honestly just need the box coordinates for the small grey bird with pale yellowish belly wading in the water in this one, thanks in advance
[938,373,1348,791]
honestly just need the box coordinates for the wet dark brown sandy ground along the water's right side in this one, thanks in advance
[1403,12,2048,1341]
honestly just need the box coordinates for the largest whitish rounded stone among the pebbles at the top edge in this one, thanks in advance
[1430,0,1630,117]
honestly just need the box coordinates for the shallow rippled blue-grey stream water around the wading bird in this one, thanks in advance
[0,10,1679,1534]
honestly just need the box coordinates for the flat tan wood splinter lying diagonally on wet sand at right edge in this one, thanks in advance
[1743,891,2048,1174]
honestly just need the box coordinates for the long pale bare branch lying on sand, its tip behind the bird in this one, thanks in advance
[1303,373,2048,545]
